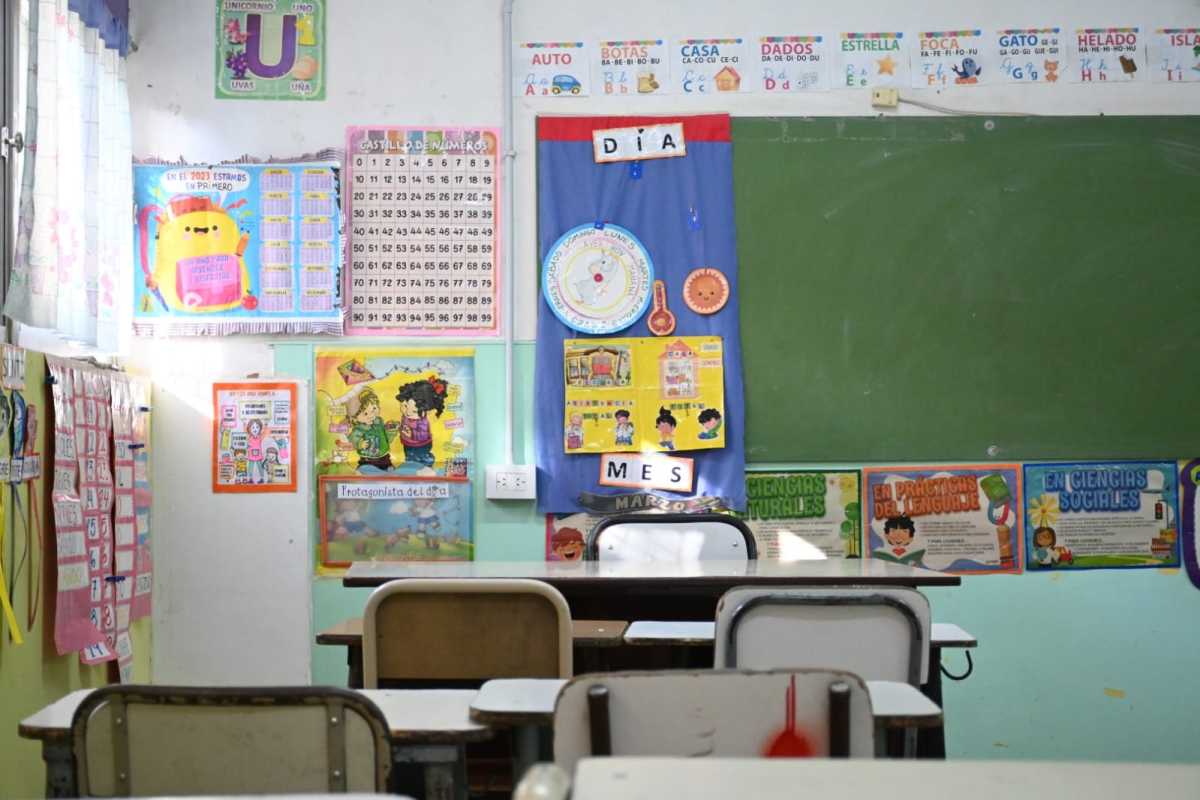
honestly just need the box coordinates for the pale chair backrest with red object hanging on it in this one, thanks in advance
[554,669,875,777]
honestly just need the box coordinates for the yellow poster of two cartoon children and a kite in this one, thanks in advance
[314,348,475,477]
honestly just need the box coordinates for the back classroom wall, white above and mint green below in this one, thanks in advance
[128,0,1200,762]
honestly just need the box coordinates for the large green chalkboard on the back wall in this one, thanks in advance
[733,116,1200,462]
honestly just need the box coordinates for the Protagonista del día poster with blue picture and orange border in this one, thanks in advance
[317,475,475,567]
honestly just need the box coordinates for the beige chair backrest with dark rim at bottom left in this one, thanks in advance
[71,685,391,796]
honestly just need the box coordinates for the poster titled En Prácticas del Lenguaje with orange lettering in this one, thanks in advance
[863,464,1021,573]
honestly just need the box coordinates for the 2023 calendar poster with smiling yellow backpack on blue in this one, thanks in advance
[133,162,342,336]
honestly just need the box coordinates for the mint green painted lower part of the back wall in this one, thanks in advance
[276,344,1200,762]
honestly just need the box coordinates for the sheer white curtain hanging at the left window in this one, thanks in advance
[4,0,133,353]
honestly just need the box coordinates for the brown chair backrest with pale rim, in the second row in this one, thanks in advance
[362,578,571,688]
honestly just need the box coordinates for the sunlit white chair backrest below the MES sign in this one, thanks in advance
[588,513,758,563]
